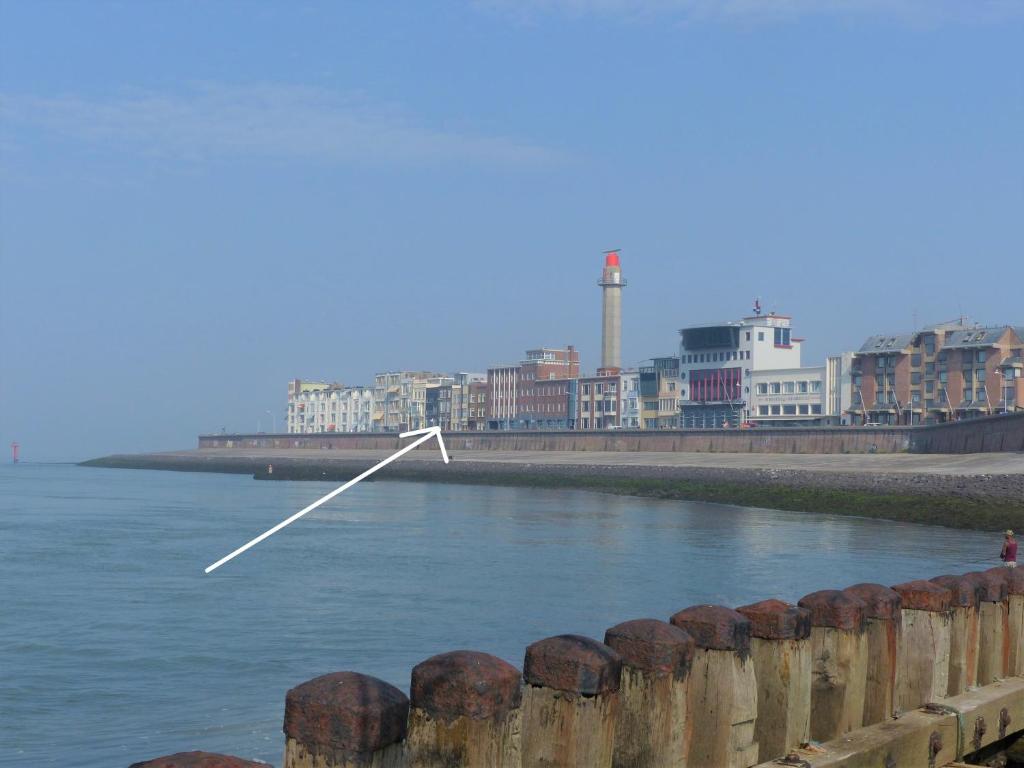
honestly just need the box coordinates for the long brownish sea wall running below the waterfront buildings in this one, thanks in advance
[199,413,1024,454]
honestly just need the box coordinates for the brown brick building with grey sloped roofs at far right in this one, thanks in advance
[849,317,1024,424]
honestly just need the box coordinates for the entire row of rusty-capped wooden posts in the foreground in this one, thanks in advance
[134,567,1024,768]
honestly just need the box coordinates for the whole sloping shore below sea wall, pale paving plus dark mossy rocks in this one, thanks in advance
[82,450,1024,530]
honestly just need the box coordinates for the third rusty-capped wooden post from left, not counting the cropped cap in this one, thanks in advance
[522,635,622,768]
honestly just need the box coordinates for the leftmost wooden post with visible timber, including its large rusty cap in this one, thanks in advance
[285,672,409,768]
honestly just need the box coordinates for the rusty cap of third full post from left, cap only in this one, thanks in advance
[522,635,623,696]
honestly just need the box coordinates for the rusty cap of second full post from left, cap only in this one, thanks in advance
[410,650,522,723]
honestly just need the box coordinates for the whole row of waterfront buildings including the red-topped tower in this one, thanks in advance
[287,251,1024,433]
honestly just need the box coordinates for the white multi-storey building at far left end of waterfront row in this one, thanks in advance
[288,379,374,433]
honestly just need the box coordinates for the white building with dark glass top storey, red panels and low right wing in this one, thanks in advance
[679,312,825,428]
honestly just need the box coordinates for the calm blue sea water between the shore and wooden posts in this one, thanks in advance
[0,465,999,768]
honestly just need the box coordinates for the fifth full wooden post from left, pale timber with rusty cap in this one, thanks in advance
[672,605,758,768]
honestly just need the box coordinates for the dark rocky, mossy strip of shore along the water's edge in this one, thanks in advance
[82,452,1024,530]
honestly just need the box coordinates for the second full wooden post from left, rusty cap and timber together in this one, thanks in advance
[406,650,522,768]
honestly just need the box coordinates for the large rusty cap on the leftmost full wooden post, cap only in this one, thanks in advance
[285,672,409,757]
